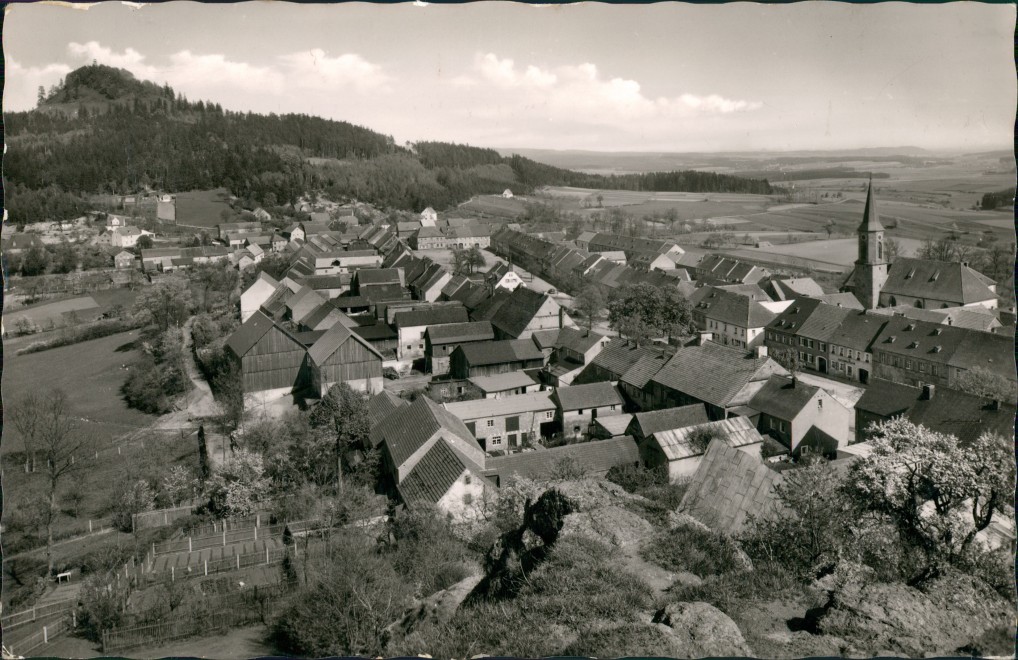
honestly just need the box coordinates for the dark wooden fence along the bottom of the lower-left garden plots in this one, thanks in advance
[103,584,289,655]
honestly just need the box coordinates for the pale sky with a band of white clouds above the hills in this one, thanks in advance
[3,2,1016,152]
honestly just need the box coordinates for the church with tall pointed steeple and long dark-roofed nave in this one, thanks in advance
[841,181,997,310]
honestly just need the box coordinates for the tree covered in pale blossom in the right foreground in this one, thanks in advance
[847,418,1015,582]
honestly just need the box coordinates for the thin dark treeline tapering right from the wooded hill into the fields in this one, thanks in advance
[509,154,774,195]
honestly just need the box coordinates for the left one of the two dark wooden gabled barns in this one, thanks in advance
[226,311,307,399]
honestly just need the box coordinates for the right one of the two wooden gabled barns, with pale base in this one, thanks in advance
[307,323,383,396]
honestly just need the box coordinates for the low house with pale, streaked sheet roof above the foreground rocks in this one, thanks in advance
[639,417,764,484]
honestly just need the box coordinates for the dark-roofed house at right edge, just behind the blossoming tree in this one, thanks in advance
[855,380,1015,444]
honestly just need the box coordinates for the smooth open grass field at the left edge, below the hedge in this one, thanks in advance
[0,330,155,453]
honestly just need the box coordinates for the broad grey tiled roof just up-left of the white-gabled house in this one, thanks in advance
[651,341,787,407]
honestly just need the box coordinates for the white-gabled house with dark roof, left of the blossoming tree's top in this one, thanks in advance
[749,375,852,456]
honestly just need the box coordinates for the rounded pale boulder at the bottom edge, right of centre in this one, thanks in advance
[653,603,753,658]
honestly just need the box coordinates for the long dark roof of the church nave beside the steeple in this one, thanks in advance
[881,257,997,305]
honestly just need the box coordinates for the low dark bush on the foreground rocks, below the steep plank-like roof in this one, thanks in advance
[640,526,741,578]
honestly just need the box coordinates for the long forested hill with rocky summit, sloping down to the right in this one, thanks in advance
[4,64,772,224]
